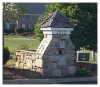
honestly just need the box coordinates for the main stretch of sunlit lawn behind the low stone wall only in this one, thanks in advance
[4,36,40,52]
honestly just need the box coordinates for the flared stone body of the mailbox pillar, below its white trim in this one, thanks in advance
[35,35,76,76]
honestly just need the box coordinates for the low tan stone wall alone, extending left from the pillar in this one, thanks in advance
[15,50,35,69]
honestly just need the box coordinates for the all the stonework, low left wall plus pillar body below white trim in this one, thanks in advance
[16,35,76,77]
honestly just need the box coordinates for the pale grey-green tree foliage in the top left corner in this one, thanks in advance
[3,3,26,23]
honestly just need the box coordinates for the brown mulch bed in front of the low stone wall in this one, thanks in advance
[3,66,40,80]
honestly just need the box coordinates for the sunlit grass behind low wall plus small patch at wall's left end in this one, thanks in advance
[4,35,40,65]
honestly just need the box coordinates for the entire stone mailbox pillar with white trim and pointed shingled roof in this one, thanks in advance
[33,11,76,77]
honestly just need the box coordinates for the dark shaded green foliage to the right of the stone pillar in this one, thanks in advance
[71,3,97,51]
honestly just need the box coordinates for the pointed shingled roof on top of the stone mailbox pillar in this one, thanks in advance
[41,10,73,28]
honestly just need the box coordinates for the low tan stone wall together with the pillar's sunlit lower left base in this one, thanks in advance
[15,50,43,75]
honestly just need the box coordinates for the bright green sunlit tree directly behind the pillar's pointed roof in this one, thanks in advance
[34,3,77,40]
